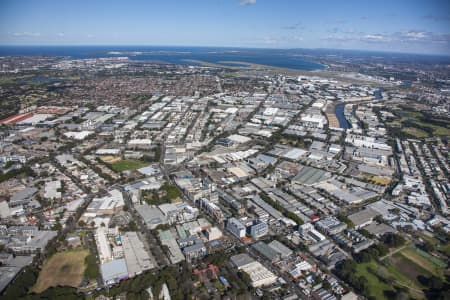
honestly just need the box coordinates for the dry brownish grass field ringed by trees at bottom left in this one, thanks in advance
[33,249,89,293]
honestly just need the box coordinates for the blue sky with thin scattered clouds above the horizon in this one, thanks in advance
[0,0,450,55]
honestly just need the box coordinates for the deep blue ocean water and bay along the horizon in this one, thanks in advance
[0,46,326,70]
